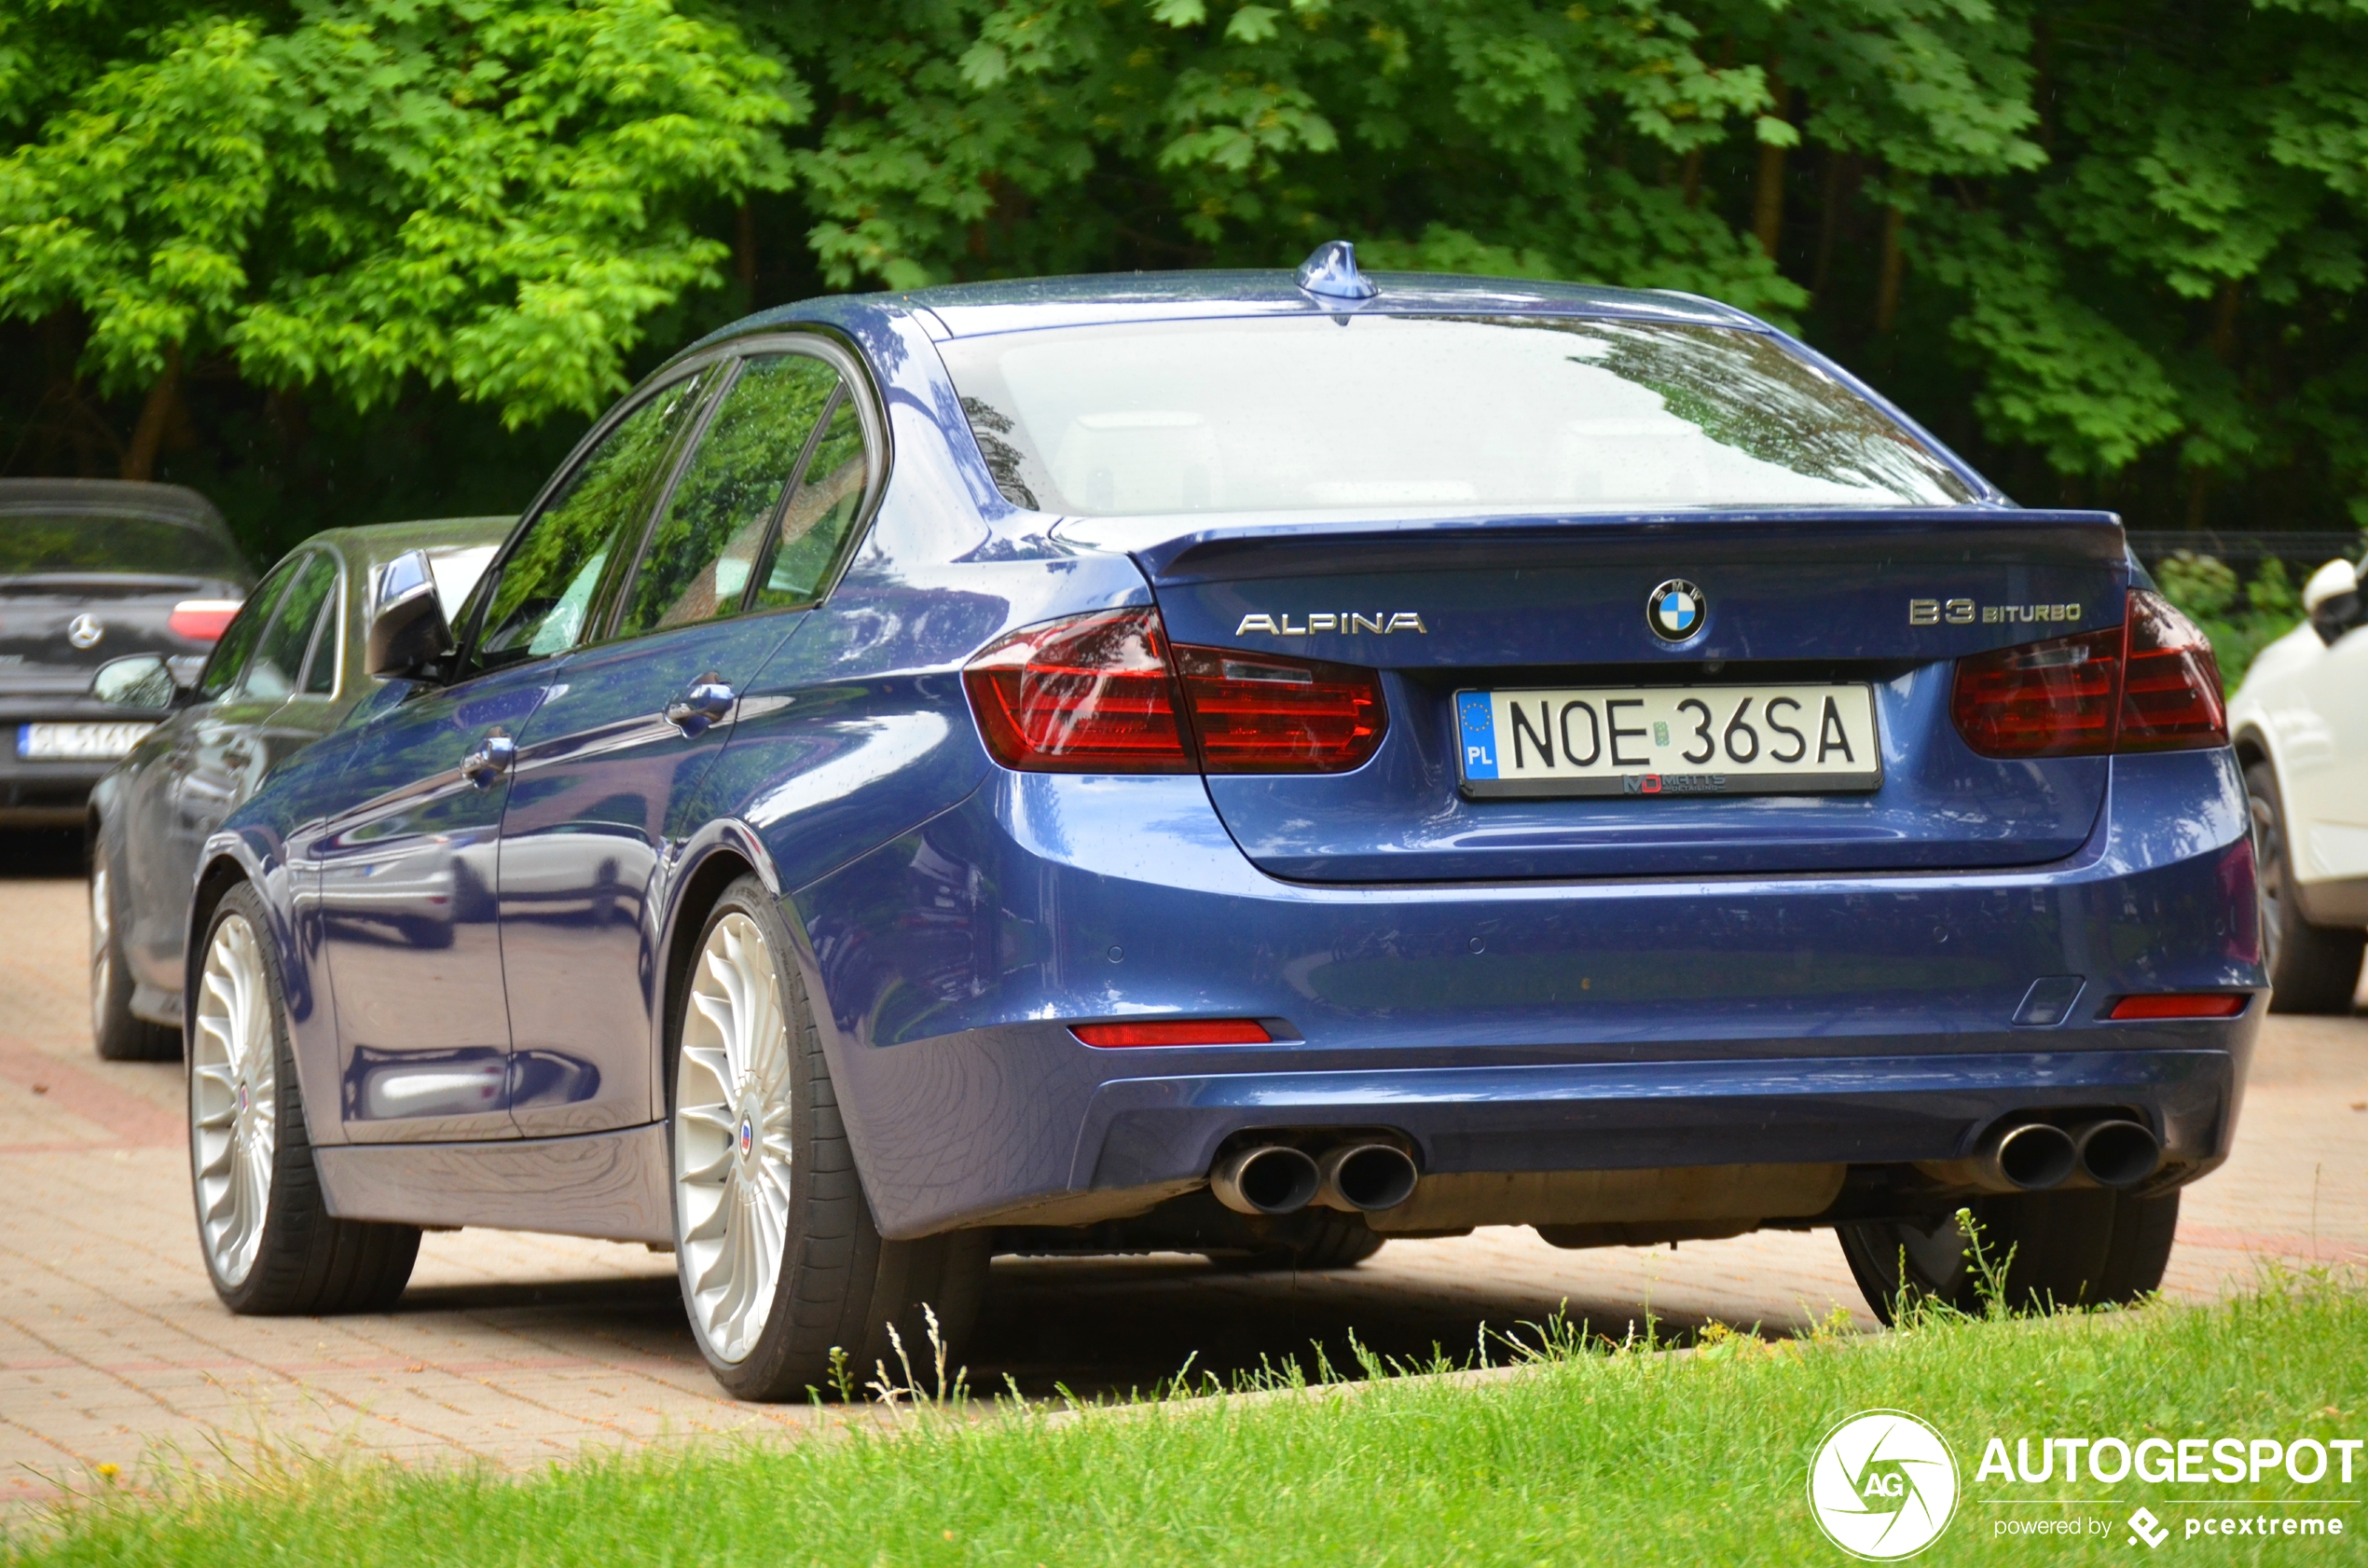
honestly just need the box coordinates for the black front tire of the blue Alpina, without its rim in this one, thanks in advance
[185,884,420,1317]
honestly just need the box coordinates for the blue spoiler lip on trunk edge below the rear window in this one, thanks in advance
[1053,504,2128,583]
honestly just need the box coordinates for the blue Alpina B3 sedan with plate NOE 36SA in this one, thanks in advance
[187,244,2264,1397]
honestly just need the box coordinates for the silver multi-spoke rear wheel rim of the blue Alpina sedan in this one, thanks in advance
[675,910,791,1364]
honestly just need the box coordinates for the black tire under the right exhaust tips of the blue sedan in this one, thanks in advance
[1836,1189,2179,1322]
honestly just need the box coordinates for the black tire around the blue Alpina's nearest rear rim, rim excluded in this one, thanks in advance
[666,876,992,1400]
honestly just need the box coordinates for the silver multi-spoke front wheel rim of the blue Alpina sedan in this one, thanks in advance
[189,915,280,1286]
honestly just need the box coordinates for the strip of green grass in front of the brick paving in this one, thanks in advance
[0,1274,2368,1568]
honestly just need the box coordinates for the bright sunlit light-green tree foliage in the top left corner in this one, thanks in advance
[0,0,805,472]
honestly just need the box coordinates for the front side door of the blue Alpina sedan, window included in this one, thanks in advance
[312,377,698,1142]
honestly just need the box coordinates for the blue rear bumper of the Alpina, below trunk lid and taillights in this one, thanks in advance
[793,753,2264,1236]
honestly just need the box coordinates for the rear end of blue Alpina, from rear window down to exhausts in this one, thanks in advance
[801,286,2262,1298]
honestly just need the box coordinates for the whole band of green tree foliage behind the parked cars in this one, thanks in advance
[0,0,2368,558]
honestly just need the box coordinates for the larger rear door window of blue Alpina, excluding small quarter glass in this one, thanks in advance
[618,353,841,637]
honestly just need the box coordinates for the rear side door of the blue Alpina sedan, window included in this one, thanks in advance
[502,341,867,1137]
